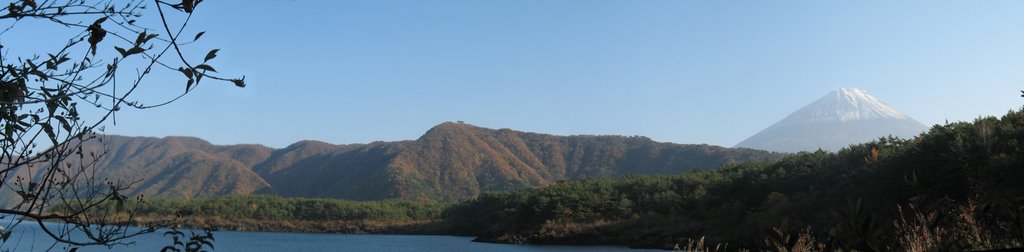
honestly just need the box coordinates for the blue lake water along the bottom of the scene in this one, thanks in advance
[0,223,654,252]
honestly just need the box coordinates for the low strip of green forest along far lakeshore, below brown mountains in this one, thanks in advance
[62,196,452,234]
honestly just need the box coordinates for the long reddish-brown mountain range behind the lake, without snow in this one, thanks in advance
[4,122,781,200]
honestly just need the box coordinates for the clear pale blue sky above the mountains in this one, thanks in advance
[8,0,1024,148]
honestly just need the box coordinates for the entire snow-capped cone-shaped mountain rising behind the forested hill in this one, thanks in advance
[736,88,927,153]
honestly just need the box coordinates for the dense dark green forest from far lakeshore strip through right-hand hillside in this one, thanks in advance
[77,112,1024,251]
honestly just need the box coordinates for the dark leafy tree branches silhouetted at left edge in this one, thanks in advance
[0,0,245,247]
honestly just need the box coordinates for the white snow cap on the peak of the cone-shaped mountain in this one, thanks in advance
[772,88,909,127]
